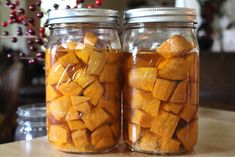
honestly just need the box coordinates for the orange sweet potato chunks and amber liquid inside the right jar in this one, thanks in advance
[124,35,199,154]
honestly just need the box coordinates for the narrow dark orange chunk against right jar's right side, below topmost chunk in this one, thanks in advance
[186,53,199,82]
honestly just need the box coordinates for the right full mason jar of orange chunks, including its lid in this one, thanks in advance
[123,8,199,154]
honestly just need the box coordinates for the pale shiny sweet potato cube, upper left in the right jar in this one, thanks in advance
[129,68,157,91]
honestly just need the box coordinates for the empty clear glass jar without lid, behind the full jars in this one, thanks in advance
[15,104,46,141]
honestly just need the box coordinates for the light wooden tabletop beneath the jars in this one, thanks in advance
[0,108,235,157]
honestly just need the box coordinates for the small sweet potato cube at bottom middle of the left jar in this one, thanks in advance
[72,129,89,151]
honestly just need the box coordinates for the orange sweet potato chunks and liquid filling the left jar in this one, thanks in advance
[46,32,120,152]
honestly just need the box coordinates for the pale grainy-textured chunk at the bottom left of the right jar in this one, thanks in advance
[139,131,162,151]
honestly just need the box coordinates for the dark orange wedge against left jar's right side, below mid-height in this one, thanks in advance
[98,97,120,119]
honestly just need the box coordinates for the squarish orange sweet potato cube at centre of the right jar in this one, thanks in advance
[153,79,177,101]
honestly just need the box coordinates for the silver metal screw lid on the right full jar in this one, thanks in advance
[124,8,197,24]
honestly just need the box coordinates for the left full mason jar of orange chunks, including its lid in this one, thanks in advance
[46,9,121,153]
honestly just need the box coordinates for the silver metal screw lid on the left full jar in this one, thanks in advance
[48,9,119,25]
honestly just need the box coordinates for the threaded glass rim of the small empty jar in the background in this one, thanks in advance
[16,103,46,118]
